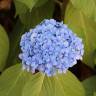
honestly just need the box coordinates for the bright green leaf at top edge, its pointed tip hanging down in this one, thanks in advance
[15,0,48,11]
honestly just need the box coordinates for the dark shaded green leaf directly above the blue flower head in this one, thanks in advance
[20,0,54,28]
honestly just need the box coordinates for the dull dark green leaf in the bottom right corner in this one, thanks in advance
[83,76,96,96]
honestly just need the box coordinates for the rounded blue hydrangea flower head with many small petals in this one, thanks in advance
[19,19,84,76]
